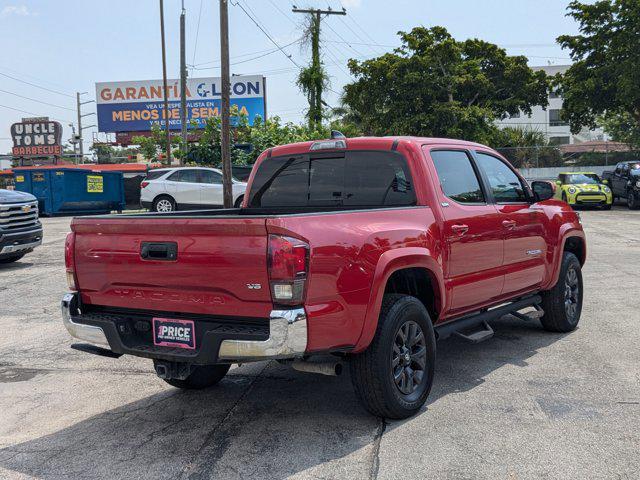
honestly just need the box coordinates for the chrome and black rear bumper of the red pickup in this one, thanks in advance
[61,293,307,365]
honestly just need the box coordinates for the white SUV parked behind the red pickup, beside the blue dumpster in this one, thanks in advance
[140,167,247,212]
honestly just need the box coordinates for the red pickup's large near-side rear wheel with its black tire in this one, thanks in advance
[350,294,436,419]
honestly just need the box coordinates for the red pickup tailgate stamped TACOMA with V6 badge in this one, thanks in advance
[71,216,272,318]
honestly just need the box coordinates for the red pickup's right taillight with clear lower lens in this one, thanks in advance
[268,235,309,305]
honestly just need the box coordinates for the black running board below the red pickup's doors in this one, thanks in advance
[434,295,544,343]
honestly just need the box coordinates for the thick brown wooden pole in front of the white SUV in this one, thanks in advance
[219,0,233,208]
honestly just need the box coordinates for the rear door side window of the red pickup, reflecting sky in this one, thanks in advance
[431,150,486,204]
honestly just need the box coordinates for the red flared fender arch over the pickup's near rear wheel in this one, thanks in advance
[353,247,446,353]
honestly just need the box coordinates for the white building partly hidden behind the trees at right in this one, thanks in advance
[497,65,608,145]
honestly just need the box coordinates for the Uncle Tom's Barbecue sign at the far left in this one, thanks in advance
[11,117,62,157]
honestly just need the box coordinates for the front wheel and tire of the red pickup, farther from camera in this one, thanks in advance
[540,252,583,333]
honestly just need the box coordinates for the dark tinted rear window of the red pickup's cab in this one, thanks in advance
[249,151,416,208]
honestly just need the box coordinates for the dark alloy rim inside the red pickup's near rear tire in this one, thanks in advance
[391,320,427,395]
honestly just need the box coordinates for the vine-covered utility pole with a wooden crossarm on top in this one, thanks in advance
[291,6,347,129]
